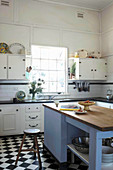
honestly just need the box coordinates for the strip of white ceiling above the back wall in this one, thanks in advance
[40,0,113,10]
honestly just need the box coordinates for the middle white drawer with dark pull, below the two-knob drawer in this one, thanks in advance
[25,112,40,121]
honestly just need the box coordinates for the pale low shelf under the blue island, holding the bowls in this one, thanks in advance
[67,144,89,165]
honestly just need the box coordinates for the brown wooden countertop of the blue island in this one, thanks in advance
[43,103,113,131]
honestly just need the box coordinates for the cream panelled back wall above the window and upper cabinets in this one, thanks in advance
[0,0,100,53]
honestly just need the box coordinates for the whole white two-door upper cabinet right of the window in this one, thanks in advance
[69,58,107,80]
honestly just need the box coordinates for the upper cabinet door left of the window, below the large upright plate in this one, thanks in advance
[8,55,25,79]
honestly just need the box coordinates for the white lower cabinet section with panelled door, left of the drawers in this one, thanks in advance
[0,105,21,136]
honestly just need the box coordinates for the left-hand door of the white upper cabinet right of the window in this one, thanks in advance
[79,59,93,80]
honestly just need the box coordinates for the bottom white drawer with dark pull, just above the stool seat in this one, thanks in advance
[25,121,40,129]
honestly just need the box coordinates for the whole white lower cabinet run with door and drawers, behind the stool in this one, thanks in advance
[0,103,44,136]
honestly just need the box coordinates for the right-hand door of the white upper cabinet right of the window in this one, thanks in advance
[94,59,107,80]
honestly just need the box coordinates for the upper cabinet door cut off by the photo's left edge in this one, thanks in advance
[0,54,7,79]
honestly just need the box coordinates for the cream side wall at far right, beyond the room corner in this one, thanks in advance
[101,5,113,82]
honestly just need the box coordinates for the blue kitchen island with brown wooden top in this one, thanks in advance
[44,103,113,170]
